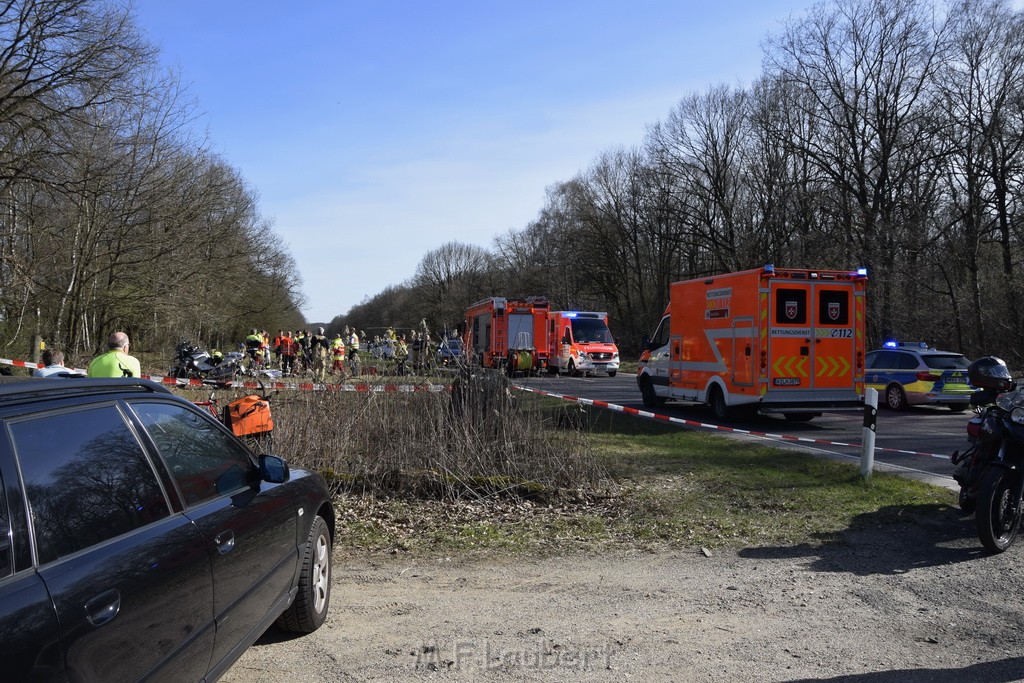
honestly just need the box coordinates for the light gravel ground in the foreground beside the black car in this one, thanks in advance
[222,513,1024,683]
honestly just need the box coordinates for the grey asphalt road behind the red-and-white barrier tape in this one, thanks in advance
[516,374,973,486]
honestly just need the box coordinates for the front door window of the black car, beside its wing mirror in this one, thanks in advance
[131,401,255,505]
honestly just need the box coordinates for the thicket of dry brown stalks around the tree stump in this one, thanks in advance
[260,370,601,499]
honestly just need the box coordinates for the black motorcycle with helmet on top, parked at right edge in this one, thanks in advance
[952,356,1024,553]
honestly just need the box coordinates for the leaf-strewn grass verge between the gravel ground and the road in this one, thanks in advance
[338,410,956,553]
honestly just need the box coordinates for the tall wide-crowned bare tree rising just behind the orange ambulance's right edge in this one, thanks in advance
[766,0,946,339]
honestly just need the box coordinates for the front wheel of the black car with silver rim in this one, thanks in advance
[276,515,331,633]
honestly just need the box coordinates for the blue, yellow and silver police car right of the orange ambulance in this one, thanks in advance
[864,341,974,412]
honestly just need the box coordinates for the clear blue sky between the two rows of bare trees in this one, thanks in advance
[136,0,811,323]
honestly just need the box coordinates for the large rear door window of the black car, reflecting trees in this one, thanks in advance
[8,405,170,563]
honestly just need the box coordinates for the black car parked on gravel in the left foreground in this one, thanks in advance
[0,378,334,681]
